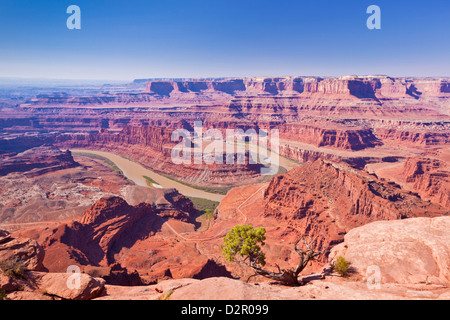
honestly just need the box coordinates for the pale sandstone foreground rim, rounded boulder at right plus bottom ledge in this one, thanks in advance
[99,217,450,301]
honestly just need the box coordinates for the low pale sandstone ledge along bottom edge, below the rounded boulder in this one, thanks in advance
[96,276,450,301]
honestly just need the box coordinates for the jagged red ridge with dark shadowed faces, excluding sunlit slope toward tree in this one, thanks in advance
[43,197,172,272]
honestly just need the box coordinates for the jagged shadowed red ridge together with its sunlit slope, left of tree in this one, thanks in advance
[43,189,229,285]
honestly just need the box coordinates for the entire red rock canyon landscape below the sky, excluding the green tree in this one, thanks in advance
[0,76,450,300]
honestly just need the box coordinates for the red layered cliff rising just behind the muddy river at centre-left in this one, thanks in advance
[55,122,262,187]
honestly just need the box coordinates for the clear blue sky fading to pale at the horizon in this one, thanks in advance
[0,0,450,80]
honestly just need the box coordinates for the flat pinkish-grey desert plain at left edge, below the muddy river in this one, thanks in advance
[0,154,130,226]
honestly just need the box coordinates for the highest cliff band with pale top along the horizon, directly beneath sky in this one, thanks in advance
[144,76,450,99]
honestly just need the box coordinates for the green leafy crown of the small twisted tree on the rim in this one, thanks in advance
[221,225,266,266]
